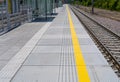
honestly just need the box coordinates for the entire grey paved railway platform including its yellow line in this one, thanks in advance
[0,5,120,82]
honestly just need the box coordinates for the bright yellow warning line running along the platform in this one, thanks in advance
[67,5,90,82]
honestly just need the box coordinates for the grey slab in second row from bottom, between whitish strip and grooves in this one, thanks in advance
[24,53,61,66]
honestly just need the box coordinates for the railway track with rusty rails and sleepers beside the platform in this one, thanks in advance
[70,6,120,77]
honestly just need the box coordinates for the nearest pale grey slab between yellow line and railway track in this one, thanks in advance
[87,66,120,82]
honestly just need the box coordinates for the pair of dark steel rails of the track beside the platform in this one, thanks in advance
[70,6,120,77]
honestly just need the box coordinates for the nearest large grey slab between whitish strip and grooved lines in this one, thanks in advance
[11,66,59,82]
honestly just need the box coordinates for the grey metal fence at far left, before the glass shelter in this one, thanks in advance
[0,0,27,35]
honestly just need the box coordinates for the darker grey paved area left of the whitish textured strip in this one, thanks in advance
[0,22,46,70]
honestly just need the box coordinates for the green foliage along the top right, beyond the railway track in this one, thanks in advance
[74,0,120,11]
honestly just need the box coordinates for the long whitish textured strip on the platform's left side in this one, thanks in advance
[0,22,52,82]
